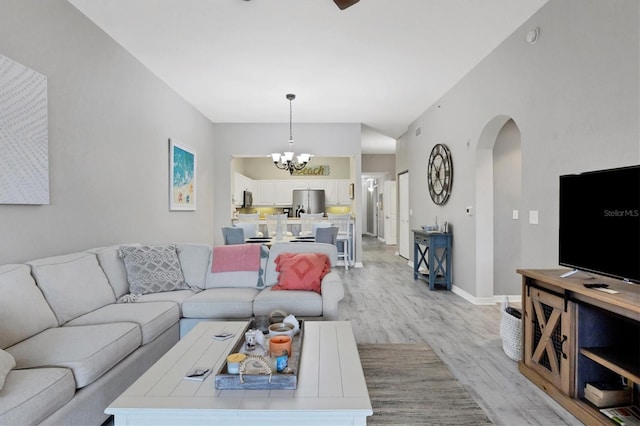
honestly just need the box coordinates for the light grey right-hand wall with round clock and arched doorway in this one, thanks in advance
[396,0,640,300]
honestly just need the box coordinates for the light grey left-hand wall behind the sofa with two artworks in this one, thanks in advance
[0,0,214,264]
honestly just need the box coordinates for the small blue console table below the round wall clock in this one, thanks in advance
[413,229,451,290]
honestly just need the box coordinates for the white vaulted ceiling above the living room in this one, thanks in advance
[69,0,548,153]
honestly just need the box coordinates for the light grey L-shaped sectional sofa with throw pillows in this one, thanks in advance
[0,243,344,425]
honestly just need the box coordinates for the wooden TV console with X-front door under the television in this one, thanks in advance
[517,269,640,425]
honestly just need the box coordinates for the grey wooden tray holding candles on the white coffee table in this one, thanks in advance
[215,320,304,389]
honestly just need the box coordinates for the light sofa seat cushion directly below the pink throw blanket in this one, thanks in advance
[182,288,260,318]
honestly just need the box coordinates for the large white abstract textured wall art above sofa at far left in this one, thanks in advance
[0,54,49,204]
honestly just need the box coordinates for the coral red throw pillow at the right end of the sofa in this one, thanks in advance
[273,253,331,293]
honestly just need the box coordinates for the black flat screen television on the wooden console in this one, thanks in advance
[559,165,640,284]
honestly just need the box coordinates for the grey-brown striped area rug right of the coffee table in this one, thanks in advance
[358,344,493,425]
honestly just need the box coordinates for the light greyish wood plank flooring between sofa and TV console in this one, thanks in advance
[338,236,582,426]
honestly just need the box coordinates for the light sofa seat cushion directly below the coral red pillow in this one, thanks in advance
[253,286,323,317]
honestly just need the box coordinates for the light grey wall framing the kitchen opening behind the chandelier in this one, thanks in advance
[213,123,362,261]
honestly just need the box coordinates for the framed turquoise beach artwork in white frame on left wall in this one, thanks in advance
[169,139,196,211]
